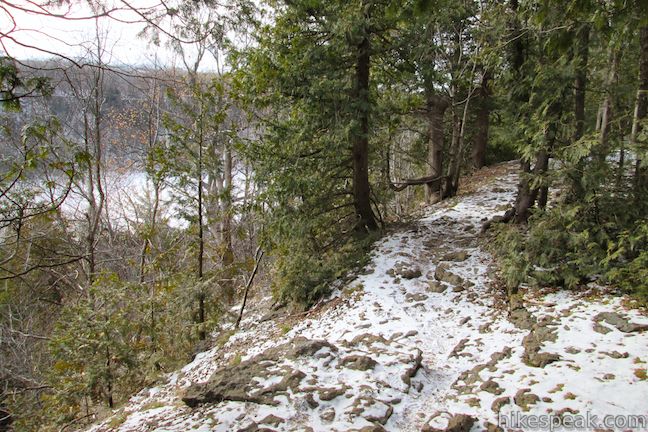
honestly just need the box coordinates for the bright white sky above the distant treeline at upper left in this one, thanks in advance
[0,0,220,70]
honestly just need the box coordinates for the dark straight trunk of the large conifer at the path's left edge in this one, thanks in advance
[352,24,378,231]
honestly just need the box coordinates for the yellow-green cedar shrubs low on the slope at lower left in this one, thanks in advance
[43,274,219,424]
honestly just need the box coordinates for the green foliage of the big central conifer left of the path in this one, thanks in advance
[235,1,400,305]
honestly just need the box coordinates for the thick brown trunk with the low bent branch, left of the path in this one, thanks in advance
[425,92,450,204]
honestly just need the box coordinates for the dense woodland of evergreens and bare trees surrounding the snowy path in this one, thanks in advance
[0,0,648,430]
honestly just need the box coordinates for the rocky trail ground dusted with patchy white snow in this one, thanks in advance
[86,164,648,432]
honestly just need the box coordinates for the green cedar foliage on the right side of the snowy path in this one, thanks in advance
[486,2,648,302]
